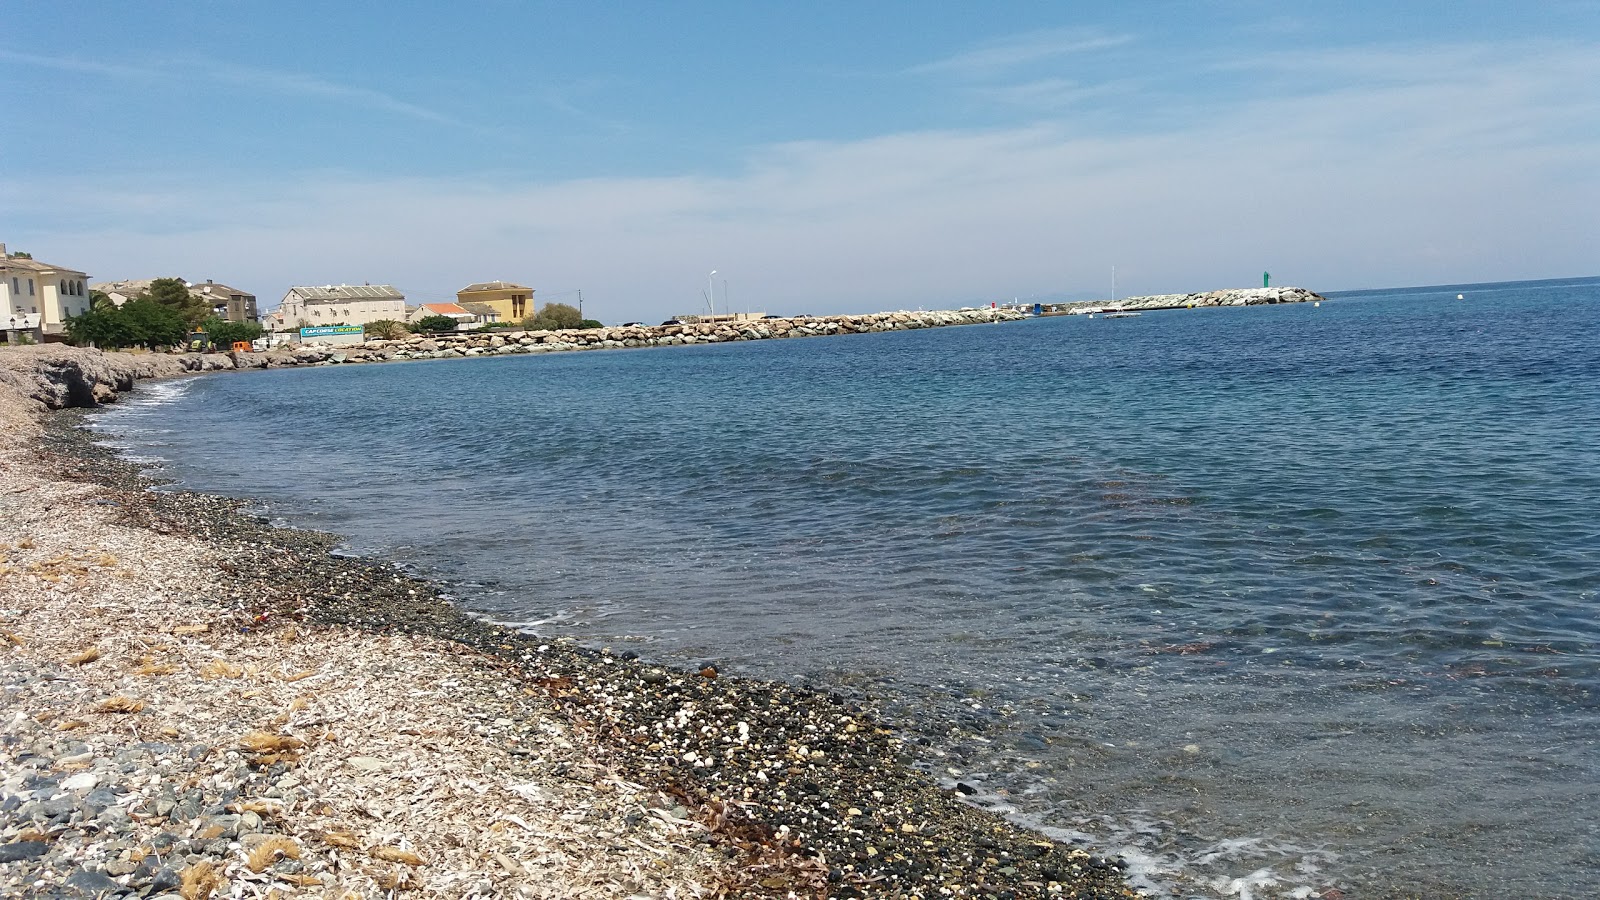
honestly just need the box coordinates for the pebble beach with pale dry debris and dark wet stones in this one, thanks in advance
[0,347,1138,898]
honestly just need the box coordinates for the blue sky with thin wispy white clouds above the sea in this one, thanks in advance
[0,0,1600,323]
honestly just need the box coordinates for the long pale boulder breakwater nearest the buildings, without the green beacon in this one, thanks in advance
[345,309,1022,362]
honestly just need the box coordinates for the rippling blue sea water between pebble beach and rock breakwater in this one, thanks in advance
[98,279,1600,898]
